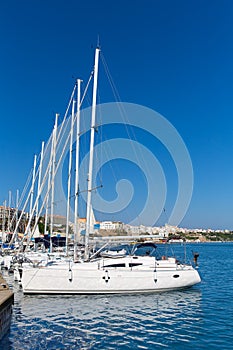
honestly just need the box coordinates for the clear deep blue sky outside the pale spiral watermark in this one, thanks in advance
[0,0,233,229]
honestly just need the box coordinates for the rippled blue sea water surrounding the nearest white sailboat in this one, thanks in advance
[0,243,233,350]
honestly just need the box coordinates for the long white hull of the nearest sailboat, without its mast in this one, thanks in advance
[22,256,201,294]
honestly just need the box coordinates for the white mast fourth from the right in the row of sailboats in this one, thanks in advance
[50,113,59,253]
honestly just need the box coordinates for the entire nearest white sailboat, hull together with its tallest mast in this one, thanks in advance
[21,48,201,294]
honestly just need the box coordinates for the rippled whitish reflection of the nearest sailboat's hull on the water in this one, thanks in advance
[13,288,202,349]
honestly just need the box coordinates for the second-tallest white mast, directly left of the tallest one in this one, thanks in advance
[74,79,82,258]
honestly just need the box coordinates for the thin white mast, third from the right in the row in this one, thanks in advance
[66,100,75,255]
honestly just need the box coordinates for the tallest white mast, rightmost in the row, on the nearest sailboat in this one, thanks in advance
[84,47,100,260]
